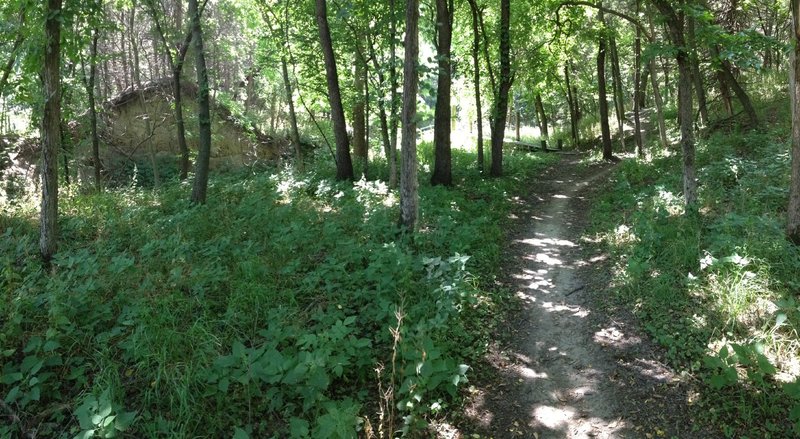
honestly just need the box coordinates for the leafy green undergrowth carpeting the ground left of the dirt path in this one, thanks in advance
[0,145,555,438]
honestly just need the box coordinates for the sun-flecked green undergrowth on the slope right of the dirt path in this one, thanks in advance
[593,102,800,438]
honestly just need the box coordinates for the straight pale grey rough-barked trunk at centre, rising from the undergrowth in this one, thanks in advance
[400,0,419,232]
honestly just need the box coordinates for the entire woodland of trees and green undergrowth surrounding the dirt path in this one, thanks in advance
[0,0,800,438]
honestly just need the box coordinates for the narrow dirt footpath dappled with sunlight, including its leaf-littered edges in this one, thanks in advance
[456,154,720,438]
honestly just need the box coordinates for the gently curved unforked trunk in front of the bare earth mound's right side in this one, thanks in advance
[189,0,211,204]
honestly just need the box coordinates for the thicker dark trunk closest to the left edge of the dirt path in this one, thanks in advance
[490,0,513,177]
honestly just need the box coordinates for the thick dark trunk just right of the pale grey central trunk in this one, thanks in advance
[431,0,453,186]
